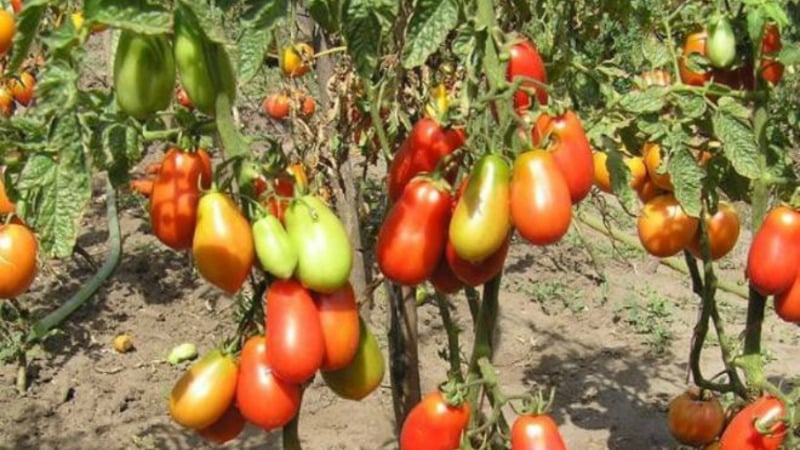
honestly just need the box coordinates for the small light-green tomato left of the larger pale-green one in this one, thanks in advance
[253,215,297,280]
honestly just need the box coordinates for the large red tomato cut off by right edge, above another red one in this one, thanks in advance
[747,206,800,295]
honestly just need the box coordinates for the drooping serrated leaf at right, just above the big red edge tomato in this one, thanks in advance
[712,109,760,179]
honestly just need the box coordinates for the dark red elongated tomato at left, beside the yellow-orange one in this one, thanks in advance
[150,148,211,250]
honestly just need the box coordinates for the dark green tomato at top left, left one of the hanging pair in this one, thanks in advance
[114,30,175,120]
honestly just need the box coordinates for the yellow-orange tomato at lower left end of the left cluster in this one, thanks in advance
[169,350,238,430]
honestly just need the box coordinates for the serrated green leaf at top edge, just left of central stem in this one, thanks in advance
[403,0,458,69]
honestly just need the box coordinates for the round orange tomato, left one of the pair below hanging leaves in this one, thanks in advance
[636,194,698,258]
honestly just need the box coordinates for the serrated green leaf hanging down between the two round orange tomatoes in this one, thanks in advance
[667,145,706,217]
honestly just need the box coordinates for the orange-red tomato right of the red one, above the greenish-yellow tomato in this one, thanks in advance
[314,282,358,370]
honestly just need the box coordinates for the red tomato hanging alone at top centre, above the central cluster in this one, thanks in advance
[506,39,547,113]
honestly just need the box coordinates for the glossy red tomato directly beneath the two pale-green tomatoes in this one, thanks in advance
[265,280,324,384]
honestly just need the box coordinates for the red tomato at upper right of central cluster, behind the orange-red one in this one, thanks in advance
[533,111,594,203]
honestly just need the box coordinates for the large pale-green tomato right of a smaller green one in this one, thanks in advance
[284,195,353,294]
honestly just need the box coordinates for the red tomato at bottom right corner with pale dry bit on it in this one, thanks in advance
[720,395,788,450]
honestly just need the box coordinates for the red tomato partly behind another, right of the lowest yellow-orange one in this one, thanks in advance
[236,336,300,431]
